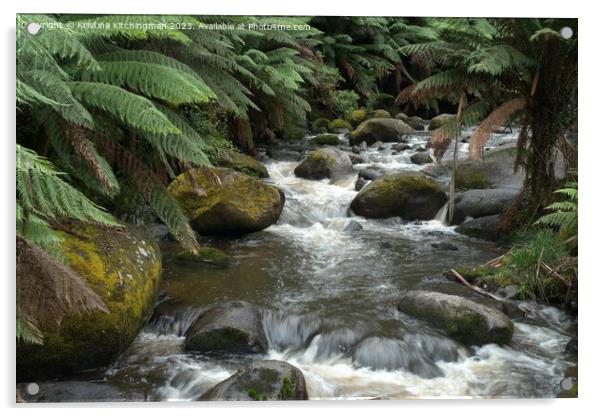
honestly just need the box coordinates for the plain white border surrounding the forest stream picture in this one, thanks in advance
[0,0,602,416]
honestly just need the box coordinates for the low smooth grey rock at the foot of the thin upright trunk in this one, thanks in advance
[452,189,518,224]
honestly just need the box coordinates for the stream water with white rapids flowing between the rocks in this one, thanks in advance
[74,132,573,400]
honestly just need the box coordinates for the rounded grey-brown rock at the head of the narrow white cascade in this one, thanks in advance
[295,147,353,180]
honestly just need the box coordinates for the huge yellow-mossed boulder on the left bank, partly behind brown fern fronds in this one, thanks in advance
[17,224,161,381]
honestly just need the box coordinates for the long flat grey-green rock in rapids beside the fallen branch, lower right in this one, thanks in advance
[398,290,514,345]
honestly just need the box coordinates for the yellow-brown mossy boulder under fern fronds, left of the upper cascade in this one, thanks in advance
[167,168,284,235]
